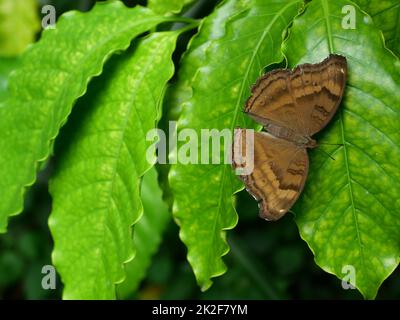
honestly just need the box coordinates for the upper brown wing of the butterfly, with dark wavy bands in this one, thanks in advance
[245,54,347,136]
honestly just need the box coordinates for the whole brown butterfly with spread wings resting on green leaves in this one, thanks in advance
[232,54,347,220]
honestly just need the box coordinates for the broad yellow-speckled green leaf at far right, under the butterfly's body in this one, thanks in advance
[283,0,400,298]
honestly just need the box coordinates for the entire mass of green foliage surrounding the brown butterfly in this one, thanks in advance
[0,0,400,299]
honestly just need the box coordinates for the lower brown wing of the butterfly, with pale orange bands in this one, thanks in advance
[233,129,308,220]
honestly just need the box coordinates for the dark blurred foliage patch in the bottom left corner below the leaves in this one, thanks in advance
[0,168,62,299]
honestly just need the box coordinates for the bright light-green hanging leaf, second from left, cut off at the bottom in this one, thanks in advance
[49,32,178,299]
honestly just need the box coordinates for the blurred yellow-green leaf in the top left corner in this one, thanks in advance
[0,0,40,56]
